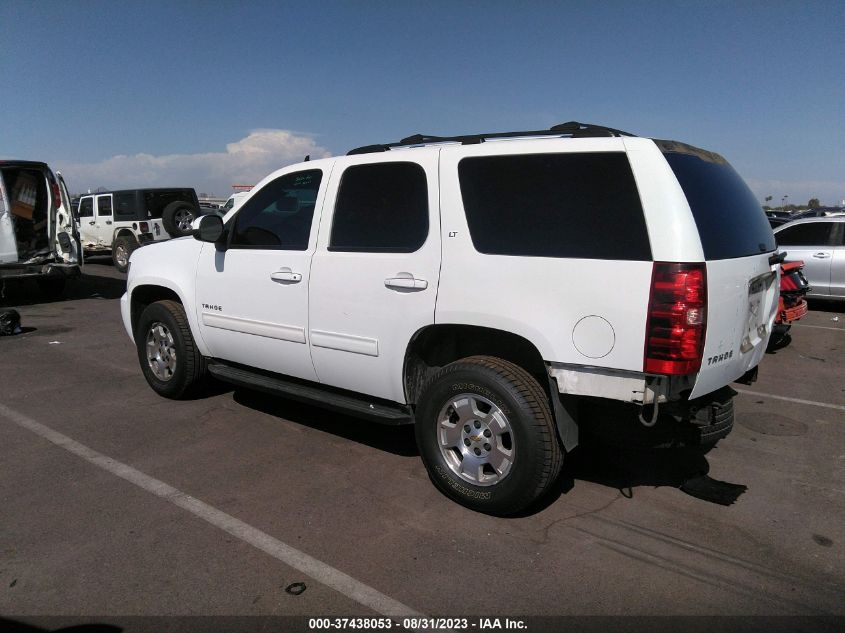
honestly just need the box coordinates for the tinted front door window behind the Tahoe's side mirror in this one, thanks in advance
[230,169,323,251]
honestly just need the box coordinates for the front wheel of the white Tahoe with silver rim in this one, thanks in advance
[135,300,206,399]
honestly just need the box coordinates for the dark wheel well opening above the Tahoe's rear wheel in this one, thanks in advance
[405,325,548,403]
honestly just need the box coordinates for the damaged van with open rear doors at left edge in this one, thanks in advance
[0,160,82,296]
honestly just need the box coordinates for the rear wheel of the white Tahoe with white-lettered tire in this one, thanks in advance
[416,356,563,515]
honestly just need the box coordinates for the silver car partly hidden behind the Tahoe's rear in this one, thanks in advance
[775,216,845,299]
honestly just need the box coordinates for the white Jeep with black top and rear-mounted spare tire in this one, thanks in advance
[77,188,201,272]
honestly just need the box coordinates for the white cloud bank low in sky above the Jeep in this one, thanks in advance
[56,129,331,197]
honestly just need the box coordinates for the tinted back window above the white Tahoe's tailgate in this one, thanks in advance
[655,141,776,259]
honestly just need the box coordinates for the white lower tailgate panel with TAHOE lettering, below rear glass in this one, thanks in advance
[690,254,780,398]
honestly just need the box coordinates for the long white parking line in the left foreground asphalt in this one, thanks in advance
[0,404,424,617]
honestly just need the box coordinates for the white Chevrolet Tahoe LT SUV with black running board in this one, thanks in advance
[121,122,780,514]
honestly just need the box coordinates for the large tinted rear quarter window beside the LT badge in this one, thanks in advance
[458,152,651,261]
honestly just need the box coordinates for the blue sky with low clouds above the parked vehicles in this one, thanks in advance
[0,0,845,204]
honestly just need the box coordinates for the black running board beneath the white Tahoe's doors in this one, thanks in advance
[208,362,414,425]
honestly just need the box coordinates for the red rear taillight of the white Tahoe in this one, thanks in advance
[643,262,707,374]
